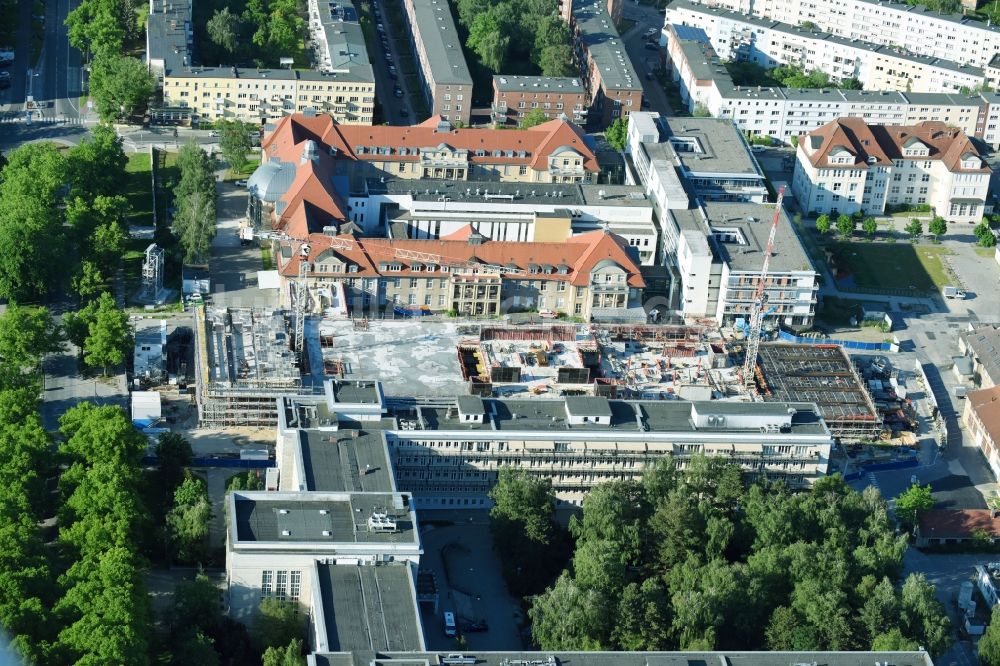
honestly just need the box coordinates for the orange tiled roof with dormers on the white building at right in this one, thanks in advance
[799,118,990,173]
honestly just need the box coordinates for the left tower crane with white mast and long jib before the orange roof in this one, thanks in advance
[240,227,527,354]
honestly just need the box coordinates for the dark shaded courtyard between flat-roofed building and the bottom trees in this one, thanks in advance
[418,510,522,651]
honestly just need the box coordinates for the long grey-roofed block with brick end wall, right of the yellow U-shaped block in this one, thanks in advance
[403,0,472,125]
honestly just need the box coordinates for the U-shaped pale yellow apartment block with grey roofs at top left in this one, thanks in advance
[147,0,375,124]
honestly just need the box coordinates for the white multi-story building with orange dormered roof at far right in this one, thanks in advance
[792,118,991,223]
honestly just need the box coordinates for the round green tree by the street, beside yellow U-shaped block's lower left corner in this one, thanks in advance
[90,53,156,122]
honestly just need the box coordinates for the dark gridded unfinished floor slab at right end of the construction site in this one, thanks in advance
[755,343,882,442]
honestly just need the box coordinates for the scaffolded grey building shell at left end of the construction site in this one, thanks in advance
[194,307,322,427]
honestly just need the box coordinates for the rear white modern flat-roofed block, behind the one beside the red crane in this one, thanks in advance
[626,111,767,208]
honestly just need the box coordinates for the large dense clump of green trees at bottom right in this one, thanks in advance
[529,457,948,654]
